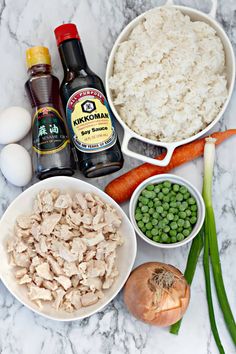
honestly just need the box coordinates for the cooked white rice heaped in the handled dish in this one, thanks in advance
[109,7,227,142]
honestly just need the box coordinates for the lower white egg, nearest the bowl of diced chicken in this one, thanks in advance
[0,144,32,187]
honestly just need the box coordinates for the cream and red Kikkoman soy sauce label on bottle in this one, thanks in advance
[66,88,117,153]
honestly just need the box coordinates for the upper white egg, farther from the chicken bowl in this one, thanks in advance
[0,106,31,144]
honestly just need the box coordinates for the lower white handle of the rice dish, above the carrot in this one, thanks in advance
[121,130,178,167]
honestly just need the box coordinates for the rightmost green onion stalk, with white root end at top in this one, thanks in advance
[202,138,236,344]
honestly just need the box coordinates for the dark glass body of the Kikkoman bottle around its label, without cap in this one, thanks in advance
[59,39,123,177]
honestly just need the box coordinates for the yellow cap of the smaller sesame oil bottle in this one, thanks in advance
[26,47,51,68]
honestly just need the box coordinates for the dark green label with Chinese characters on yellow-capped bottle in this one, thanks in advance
[32,107,69,155]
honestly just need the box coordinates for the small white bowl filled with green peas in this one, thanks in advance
[129,174,205,248]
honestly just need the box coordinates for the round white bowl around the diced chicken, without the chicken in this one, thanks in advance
[0,177,137,321]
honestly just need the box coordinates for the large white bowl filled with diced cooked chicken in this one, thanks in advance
[0,177,137,321]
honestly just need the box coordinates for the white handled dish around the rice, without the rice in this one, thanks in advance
[105,0,235,166]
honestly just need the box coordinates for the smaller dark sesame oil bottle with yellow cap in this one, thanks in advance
[25,47,74,179]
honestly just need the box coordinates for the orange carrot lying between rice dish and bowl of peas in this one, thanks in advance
[105,129,236,203]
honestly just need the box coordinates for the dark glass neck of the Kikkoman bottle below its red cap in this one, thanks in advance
[59,39,88,71]
